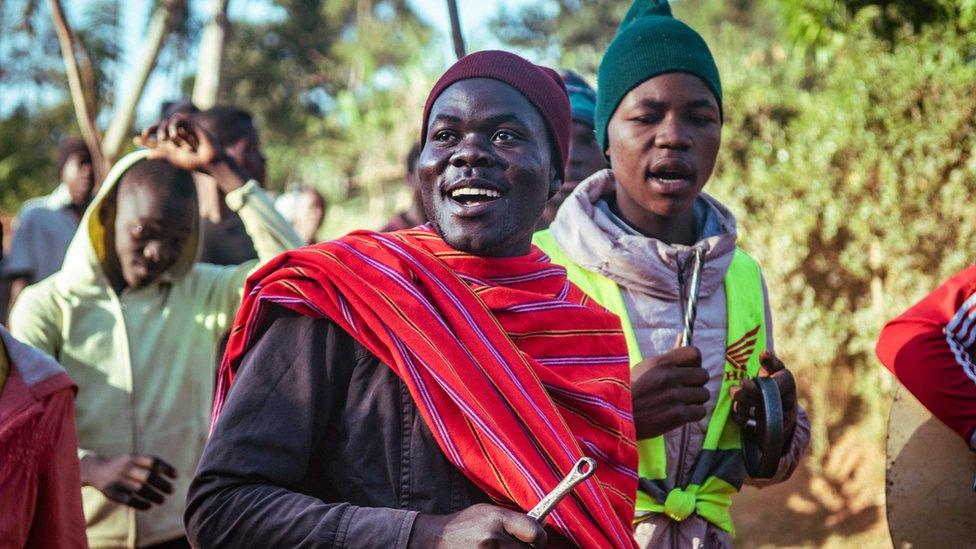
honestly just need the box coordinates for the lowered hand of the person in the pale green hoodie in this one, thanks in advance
[81,454,176,511]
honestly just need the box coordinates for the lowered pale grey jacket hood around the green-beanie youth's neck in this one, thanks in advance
[550,169,738,301]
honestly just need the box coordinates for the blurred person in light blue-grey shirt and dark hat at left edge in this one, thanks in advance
[0,137,95,306]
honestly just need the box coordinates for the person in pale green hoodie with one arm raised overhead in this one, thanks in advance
[10,117,301,547]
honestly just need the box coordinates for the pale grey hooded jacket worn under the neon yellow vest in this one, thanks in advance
[550,169,810,548]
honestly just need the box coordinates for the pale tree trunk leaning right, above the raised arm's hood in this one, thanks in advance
[102,1,175,163]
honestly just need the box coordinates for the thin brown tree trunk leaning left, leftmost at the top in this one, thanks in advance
[48,0,108,182]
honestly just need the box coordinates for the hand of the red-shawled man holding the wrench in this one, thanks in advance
[409,503,547,548]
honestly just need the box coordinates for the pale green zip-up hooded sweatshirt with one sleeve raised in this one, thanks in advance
[10,151,302,548]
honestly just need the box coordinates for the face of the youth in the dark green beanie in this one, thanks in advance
[607,73,722,228]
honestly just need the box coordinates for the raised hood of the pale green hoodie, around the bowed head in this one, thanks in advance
[54,149,200,295]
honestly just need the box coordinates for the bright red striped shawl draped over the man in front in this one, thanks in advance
[214,229,637,547]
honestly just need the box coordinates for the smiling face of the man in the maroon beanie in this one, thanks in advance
[417,78,560,257]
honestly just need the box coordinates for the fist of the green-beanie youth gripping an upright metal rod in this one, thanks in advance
[630,347,711,439]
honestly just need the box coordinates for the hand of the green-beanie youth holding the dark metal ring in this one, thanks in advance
[729,351,796,453]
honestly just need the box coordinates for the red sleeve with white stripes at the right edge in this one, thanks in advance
[877,267,976,445]
